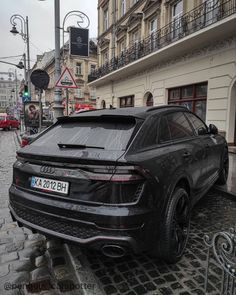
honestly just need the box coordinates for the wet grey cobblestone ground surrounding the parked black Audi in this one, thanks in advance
[0,130,236,295]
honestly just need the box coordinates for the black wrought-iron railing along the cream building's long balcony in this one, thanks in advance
[88,0,236,82]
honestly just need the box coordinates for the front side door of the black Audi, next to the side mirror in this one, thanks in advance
[186,112,221,186]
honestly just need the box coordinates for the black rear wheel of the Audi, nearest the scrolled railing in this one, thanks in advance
[155,187,190,263]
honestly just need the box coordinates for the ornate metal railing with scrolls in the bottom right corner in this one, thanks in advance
[204,227,236,295]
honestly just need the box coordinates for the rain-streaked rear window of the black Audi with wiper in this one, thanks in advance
[31,120,135,150]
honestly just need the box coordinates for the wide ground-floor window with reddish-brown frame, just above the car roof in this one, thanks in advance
[168,83,207,121]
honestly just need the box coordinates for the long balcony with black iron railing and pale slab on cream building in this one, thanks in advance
[88,0,236,86]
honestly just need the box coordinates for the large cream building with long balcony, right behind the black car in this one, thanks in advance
[89,0,236,143]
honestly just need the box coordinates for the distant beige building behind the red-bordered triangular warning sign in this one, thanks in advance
[32,40,98,113]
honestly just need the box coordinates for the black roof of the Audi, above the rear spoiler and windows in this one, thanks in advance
[65,105,188,119]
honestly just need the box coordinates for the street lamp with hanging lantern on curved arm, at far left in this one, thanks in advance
[10,14,31,95]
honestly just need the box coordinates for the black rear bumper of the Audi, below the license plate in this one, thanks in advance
[9,185,153,253]
